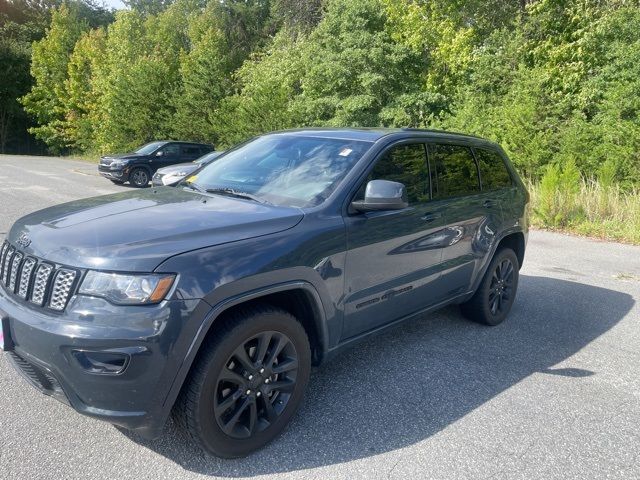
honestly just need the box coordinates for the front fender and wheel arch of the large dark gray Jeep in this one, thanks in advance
[155,216,346,430]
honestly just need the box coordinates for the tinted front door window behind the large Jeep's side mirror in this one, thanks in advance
[356,143,429,204]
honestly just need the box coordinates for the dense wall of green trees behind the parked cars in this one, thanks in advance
[7,0,640,189]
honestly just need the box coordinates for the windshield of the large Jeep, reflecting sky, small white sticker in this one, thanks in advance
[187,134,372,207]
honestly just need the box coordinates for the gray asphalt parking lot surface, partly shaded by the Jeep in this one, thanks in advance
[0,156,640,479]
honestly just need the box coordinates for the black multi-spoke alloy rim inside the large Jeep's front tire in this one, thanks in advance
[213,331,298,438]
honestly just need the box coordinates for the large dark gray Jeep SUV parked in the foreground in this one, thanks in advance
[0,129,528,457]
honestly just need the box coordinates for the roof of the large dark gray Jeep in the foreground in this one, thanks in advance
[274,127,493,143]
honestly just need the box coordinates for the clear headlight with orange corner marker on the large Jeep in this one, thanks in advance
[78,270,176,305]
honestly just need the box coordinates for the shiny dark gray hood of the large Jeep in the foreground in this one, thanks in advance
[8,188,303,272]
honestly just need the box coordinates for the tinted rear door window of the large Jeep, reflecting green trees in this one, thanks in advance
[429,144,480,198]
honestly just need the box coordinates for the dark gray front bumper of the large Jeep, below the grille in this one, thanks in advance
[0,287,210,438]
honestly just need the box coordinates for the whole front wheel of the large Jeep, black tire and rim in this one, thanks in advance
[174,305,311,458]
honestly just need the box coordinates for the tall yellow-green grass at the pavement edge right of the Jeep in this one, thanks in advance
[528,173,640,244]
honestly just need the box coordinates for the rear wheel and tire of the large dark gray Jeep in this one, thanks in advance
[460,248,519,326]
